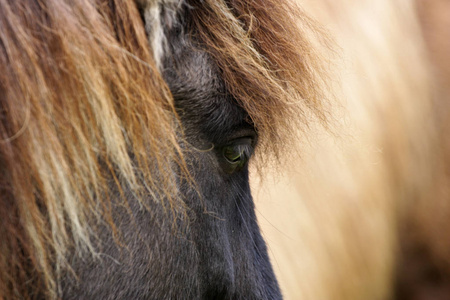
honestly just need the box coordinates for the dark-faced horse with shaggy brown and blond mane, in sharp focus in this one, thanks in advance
[0,0,329,299]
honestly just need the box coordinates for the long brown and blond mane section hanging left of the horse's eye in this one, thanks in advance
[0,1,179,299]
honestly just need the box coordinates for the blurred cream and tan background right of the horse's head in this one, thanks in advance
[252,0,450,300]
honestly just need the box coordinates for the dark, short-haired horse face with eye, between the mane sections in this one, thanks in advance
[62,2,281,299]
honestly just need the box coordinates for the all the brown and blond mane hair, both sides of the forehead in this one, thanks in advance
[0,0,325,299]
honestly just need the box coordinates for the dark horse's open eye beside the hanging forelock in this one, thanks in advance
[222,138,253,174]
